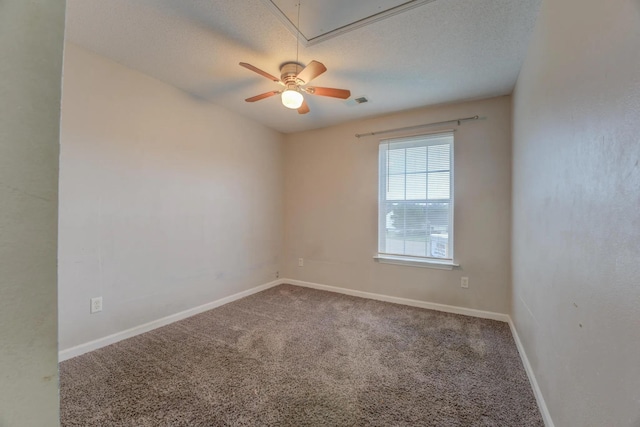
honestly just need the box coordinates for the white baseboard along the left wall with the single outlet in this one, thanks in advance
[58,280,283,362]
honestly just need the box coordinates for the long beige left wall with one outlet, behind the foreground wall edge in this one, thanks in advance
[59,45,283,350]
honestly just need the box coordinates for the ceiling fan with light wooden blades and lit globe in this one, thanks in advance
[240,61,351,114]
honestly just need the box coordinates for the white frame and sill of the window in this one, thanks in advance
[374,130,459,270]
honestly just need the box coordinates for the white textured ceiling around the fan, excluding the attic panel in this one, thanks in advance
[67,0,540,133]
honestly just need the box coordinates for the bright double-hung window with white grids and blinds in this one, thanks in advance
[376,132,453,265]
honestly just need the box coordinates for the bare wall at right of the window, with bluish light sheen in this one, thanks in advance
[512,0,640,427]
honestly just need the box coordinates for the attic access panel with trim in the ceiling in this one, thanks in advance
[263,0,435,46]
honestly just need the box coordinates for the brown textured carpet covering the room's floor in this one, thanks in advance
[60,285,544,426]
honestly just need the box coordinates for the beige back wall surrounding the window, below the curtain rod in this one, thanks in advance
[283,97,511,313]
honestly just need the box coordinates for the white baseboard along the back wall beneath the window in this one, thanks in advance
[282,279,509,322]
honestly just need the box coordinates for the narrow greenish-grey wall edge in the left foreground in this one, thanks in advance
[0,0,65,427]
